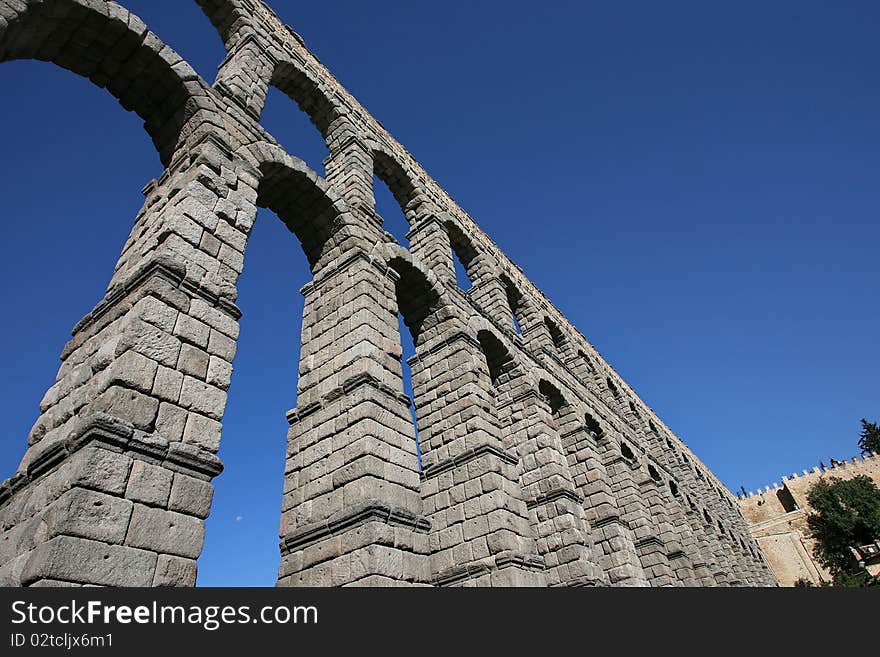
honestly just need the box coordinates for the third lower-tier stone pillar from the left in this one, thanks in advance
[410,330,545,586]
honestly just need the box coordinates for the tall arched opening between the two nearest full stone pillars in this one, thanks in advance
[199,149,350,586]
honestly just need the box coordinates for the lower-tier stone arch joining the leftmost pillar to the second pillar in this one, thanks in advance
[248,143,358,273]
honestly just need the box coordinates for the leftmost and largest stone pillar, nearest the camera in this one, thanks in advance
[0,133,248,586]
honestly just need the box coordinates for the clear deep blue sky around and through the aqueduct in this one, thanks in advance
[0,0,880,585]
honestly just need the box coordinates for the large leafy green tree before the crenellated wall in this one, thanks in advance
[807,475,880,586]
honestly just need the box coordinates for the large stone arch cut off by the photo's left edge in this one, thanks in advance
[0,0,220,166]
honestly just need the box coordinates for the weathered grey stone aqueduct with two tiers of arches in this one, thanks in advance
[0,0,773,586]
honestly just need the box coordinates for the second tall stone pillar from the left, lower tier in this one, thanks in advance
[278,251,430,586]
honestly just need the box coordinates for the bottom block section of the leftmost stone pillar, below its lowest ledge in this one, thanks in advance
[0,414,222,587]
